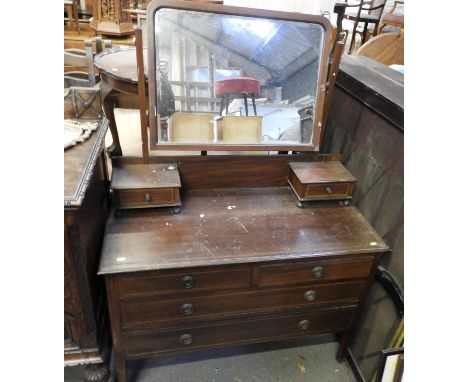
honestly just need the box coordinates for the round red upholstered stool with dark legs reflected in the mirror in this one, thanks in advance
[215,77,260,115]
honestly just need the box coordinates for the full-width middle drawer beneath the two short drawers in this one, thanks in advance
[120,281,364,330]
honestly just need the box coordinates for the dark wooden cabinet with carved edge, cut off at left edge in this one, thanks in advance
[64,124,109,381]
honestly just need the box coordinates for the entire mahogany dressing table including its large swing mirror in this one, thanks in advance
[99,1,389,382]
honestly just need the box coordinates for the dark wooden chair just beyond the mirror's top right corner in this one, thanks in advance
[344,0,387,54]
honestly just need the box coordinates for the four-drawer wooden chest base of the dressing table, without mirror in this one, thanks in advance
[99,188,388,382]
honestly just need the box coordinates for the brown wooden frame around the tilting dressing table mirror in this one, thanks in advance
[147,0,332,152]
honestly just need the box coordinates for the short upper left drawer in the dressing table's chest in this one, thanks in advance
[118,267,251,298]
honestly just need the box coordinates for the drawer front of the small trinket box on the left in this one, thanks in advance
[116,188,178,206]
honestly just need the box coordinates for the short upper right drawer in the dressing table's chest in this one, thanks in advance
[258,257,374,286]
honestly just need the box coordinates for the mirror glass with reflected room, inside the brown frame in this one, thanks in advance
[154,8,324,145]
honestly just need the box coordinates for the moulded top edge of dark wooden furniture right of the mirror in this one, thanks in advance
[336,56,404,129]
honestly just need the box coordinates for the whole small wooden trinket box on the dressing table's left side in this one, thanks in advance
[110,163,181,209]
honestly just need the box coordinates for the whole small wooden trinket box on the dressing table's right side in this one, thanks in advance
[288,161,357,202]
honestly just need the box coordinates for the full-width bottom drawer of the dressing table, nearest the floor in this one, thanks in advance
[123,308,355,357]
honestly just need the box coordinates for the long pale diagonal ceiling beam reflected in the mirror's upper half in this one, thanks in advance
[160,18,273,81]
